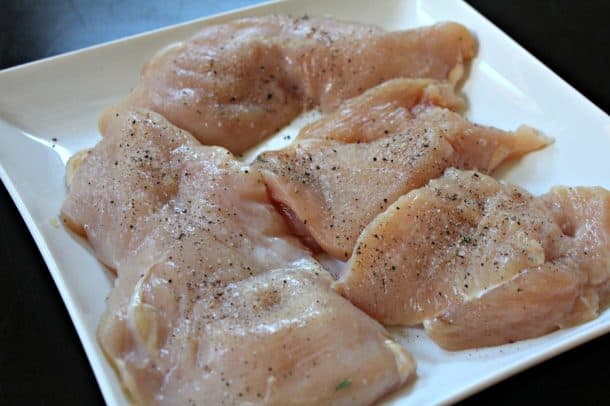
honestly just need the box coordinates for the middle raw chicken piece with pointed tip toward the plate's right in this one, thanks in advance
[256,79,549,260]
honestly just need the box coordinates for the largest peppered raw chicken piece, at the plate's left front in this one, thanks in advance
[62,111,415,405]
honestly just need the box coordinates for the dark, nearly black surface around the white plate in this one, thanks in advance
[0,0,610,405]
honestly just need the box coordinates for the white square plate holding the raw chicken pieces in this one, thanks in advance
[0,0,610,405]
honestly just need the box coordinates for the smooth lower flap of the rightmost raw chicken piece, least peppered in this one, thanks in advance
[424,187,610,349]
